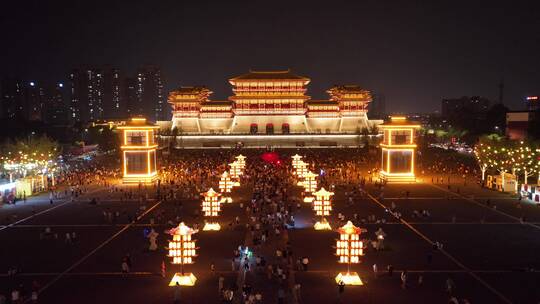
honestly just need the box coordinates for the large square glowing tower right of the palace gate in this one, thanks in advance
[379,116,420,183]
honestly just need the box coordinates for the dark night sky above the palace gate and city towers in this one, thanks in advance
[0,0,540,112]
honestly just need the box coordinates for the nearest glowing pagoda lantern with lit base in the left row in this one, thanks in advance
[166,222,198,286]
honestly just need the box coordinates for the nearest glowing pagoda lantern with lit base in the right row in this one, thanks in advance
[336,221,364,285]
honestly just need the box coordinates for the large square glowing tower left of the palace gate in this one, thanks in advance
[118,117,159,183]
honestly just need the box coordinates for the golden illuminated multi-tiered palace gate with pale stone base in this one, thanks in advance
[168,70,380,141]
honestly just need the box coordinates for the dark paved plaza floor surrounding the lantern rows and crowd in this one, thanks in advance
[0,154,540,304]
